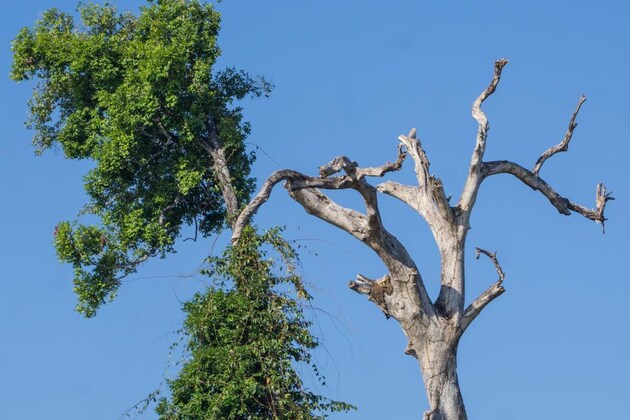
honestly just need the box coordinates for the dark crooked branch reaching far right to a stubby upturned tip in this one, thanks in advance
[483,160,614,229]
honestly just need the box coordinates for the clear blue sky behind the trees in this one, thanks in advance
[0,0,630,420]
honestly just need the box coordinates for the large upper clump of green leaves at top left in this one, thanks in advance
[11,0,269,316]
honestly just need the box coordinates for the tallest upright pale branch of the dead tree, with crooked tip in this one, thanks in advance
[458,58,508,215]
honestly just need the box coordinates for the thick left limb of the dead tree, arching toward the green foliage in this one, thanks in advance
[232,149,435,320]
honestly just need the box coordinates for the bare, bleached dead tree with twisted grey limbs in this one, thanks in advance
[232,59,613,420]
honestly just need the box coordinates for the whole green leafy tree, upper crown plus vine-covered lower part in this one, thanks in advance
[11,0,356,418]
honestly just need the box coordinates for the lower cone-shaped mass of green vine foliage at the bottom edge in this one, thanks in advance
[156,228,354,420]
